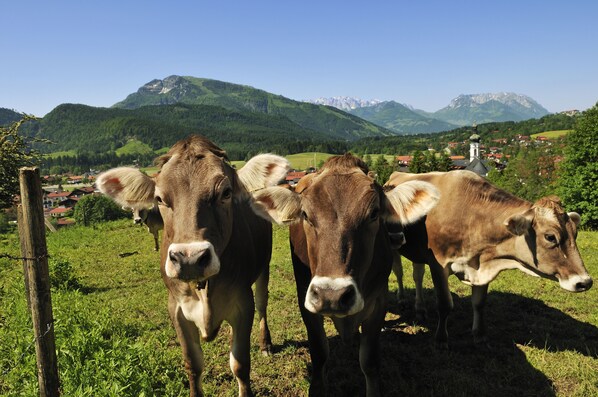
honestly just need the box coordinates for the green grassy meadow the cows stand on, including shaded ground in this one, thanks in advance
[0,220,598,397]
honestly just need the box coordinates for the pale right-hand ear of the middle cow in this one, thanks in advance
[385,181,440,225]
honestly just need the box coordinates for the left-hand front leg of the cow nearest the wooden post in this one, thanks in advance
[168,294,204,397]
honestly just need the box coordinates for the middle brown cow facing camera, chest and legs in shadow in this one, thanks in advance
[248,154,438,396]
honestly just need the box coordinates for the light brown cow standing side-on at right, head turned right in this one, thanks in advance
[385,171,592,346]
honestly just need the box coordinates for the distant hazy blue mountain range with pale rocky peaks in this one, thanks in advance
[309,92,549,134]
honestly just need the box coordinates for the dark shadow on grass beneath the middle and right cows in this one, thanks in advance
[288,291,598,396]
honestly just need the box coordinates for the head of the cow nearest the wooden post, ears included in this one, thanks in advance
[97,135,289,282]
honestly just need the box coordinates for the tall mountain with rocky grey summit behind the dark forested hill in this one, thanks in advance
[113,76,395,140]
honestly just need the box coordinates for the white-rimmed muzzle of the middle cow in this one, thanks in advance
[305,276,364,317]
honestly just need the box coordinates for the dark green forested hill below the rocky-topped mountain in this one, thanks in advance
[27,104,346,159]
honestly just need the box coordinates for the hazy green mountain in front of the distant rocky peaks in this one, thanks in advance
[350,101,457,134]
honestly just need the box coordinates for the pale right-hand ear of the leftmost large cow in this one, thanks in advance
[237,154,291,193]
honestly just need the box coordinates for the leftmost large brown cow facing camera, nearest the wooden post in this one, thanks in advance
[97,136,289,396]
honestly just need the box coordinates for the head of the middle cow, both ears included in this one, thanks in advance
[248,154,439,316]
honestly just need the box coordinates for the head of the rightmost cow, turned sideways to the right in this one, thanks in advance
[505,196,592,292]
